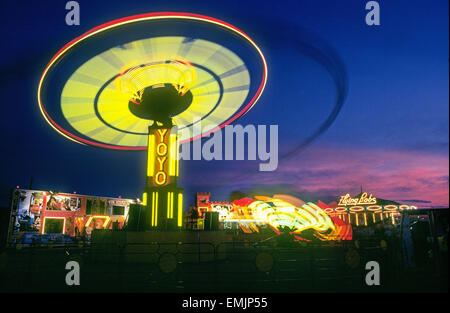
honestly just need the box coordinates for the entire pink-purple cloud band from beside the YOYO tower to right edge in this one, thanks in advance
[185,147,449,208]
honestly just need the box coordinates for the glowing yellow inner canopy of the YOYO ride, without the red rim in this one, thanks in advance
[61,37,250,146]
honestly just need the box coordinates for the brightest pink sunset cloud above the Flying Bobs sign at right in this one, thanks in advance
[272,148,449,207]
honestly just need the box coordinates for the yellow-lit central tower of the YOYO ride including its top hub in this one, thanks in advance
[115,57,197,230]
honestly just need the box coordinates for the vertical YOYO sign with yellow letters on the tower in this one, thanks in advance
[152,128,170,186]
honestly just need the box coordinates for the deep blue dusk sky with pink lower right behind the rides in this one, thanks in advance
[0,0,449,207]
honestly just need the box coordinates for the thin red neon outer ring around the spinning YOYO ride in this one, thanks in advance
[37,12,267,151]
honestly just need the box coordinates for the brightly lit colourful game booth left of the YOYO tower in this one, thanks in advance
[8,189,135,243]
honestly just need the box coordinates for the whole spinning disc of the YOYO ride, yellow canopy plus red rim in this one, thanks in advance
[38,13,267,150]
